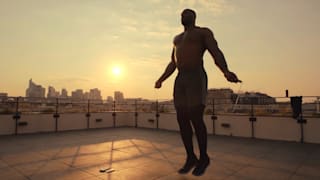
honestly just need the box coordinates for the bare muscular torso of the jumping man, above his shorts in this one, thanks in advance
[173,26,208,70]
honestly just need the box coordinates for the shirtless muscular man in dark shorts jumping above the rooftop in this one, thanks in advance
[155,9,241,176]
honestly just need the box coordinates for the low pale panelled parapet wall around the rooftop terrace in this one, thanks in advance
[0,112,320,143]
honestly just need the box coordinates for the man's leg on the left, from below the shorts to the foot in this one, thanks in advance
[176,107,198,174]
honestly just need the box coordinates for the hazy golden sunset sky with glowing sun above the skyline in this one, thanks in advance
[0,0,320,99]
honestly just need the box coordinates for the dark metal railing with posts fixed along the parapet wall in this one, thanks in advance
[0,96,320,142]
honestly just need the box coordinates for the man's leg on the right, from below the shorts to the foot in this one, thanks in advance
[190,105,210,176]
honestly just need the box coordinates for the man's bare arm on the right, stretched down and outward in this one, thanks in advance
[204,29,241,83]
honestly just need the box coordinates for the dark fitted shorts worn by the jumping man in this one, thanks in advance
[173,67,208,107]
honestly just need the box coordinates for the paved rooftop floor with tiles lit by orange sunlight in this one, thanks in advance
[0,128,320,180]
